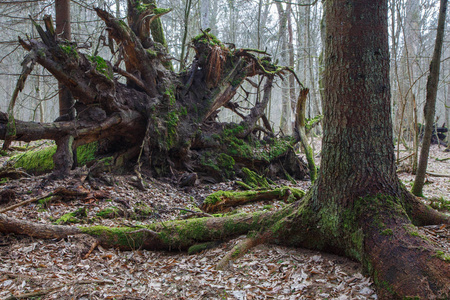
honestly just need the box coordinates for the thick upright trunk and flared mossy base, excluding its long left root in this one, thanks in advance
[274,0,450,299]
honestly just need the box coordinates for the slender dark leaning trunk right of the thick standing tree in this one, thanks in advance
[412,0,448,196]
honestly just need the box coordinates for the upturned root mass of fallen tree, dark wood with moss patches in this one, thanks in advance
[0,1,307,181]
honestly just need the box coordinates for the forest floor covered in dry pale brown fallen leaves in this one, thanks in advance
[0,145,450,299]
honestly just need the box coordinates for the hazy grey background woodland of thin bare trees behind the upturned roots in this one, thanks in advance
[0,0,450,145]
